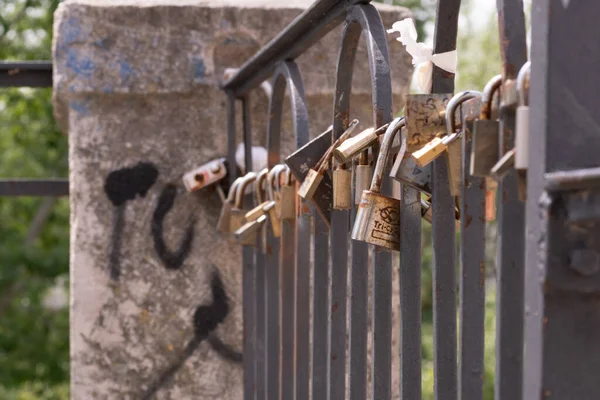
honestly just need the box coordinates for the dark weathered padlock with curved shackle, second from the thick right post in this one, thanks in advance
[469,75,502,178]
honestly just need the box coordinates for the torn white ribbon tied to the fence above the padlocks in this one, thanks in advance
[387,18,457,93]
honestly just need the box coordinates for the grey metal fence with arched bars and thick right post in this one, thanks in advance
[223,0,600,400]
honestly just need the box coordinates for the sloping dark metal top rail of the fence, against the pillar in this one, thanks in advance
[222,0,370,97]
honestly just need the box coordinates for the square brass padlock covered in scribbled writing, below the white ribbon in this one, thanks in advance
[404,93,452,153]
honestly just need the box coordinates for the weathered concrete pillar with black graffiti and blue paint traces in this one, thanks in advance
[54,0,410,400]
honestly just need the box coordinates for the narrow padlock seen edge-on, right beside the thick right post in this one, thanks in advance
[515,61,531,170]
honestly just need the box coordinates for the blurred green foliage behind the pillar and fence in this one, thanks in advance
[0,0,500,400]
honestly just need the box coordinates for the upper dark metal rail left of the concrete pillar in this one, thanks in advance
[0,61,52,87]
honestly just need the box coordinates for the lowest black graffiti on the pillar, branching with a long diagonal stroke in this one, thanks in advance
[140,268,242,400]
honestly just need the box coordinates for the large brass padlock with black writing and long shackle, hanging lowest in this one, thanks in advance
[352,118,404,251]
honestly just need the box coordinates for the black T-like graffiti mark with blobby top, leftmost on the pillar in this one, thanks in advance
[104,162,158,281]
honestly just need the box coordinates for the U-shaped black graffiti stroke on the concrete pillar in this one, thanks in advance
[152,184,196,269]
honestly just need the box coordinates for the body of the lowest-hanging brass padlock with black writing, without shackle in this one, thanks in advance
[352,190,400,251]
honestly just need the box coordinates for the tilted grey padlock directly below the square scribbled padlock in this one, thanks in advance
[390,119,431,194]
